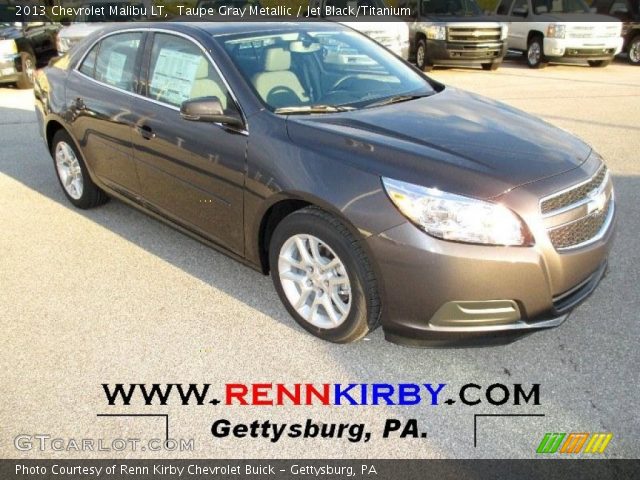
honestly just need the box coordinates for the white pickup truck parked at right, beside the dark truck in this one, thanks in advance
[496,0,622,68]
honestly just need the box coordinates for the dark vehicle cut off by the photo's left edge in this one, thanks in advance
[0,5,61,88]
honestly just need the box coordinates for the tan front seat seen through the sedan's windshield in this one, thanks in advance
[253,47,309,108]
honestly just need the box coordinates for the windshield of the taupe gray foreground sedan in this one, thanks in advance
[217,30,434,114]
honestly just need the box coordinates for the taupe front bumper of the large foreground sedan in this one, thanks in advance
[367,162,615,346]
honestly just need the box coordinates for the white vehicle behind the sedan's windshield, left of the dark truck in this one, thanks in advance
[309,0,409,60]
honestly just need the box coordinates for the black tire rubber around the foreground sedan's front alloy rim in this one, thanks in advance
[269,210,369,343]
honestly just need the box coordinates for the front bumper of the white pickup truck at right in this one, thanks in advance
[544,37,624,60]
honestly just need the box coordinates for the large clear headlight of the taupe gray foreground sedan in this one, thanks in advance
[382,178,533,246]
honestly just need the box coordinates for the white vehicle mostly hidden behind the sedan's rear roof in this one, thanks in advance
[56,0,144,55]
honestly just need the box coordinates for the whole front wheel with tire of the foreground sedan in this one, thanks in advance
[269,207,380,343]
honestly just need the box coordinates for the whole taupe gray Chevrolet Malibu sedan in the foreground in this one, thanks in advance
[35,22,614,345]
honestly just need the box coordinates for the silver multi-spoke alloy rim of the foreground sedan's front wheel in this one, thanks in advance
[278,234,352,329]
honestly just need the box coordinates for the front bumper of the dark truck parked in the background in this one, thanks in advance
[426,39,507,66]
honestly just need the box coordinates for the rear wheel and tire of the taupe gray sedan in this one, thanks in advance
[51,130,109,209]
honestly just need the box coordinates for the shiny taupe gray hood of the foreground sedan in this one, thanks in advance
[287,88,591,198]
